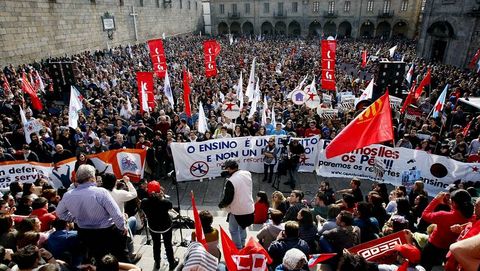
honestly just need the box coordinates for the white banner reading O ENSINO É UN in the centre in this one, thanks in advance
[171,136,319,181]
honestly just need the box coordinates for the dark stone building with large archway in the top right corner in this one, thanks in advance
[417,0,480,67]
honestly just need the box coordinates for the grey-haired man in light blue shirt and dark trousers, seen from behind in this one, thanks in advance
[56,165,129,262]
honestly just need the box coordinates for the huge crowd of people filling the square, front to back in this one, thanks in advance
[0,35,480,270]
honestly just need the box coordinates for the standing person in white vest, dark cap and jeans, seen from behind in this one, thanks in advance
[218,160,254,249]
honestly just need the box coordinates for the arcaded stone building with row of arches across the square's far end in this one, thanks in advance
[208,0,422,38]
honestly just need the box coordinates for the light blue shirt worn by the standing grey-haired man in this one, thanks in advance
[56,182,125,231]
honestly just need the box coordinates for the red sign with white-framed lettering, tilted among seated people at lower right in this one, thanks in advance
[348,231,407,264]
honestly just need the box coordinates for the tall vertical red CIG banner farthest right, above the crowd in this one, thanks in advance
[322,40,337,90]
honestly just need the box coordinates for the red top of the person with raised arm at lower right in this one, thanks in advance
[422,199,472,249]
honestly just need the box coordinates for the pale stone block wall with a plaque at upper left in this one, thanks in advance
[0,0,203,66]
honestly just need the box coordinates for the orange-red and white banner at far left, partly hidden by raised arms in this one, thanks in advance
[0,149,147,188]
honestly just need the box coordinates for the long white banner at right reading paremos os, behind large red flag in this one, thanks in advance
[317,140,480,195]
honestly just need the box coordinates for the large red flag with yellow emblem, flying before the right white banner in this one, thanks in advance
[325,89,393,158]
